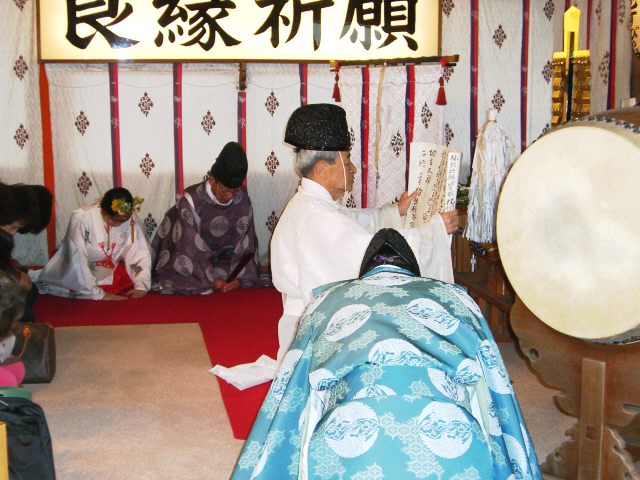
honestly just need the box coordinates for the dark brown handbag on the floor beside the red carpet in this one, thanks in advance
[12,323,56,383]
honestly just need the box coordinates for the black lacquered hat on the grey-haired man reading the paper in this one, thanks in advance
[284,103,351,152]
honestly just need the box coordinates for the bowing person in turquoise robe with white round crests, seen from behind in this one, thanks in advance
[232,229,541,480]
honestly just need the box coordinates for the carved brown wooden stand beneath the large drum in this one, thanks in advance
[511,297,640,480]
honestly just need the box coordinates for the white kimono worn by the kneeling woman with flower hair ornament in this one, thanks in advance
[37,205,151,300]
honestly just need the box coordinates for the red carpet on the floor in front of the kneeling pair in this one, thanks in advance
[35,288,282,439]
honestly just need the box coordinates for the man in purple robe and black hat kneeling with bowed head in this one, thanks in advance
[151,142,259,294]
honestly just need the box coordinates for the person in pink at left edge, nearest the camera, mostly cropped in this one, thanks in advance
[0,272,27,387]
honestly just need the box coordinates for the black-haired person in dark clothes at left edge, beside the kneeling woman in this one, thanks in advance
[0,183,53,322]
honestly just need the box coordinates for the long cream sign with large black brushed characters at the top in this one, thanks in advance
[38,0,440,62]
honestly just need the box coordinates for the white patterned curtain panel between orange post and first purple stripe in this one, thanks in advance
[47,64,113,245]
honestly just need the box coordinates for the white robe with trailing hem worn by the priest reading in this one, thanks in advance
[212,178,453,388]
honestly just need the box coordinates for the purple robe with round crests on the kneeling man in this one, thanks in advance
[151,180,259,294]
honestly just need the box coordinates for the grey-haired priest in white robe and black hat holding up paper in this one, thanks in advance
[214,104,458,388]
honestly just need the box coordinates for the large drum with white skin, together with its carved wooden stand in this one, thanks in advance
[497,107,640,480]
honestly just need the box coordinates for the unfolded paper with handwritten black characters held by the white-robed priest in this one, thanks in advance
[404,142,462,228]
